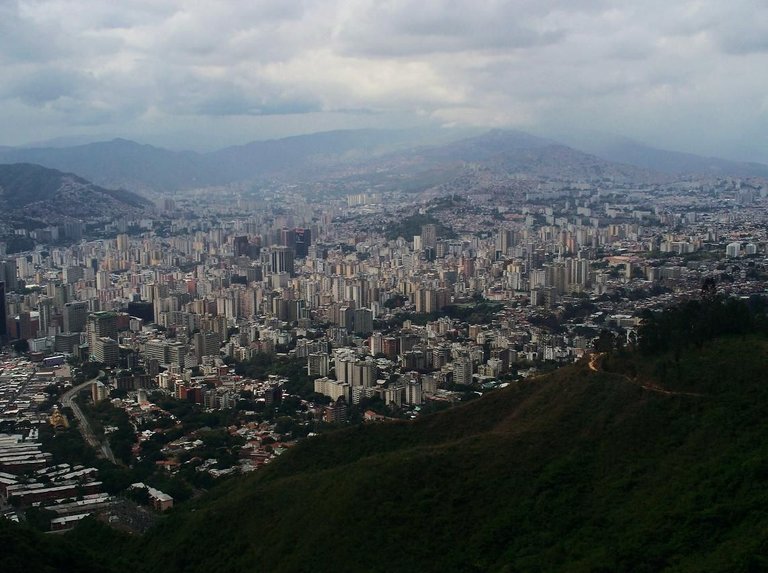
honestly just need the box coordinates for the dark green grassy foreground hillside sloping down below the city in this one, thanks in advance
[135,338,768,571]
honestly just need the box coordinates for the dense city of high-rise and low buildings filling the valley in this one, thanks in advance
[0,153,768,531]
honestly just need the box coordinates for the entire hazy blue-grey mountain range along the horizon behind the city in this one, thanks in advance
[0,130,768,192]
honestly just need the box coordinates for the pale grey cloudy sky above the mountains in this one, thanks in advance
[0,0,768,162]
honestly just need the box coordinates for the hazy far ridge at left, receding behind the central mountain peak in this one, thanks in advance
[0,129,474,192]
